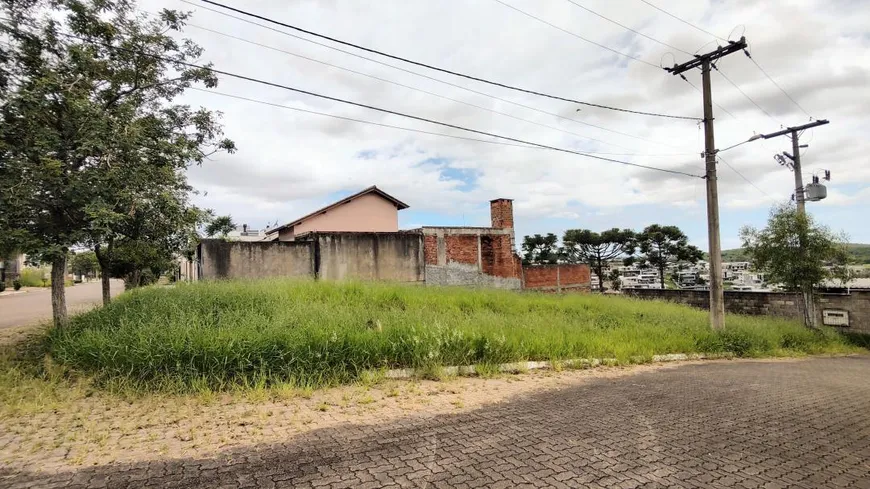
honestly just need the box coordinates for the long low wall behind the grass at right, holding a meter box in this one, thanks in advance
[623,289,870,333]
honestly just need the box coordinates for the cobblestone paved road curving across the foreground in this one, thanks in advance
[0,357,870,488]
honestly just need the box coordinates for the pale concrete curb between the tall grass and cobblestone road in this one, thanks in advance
[384,352,734,379]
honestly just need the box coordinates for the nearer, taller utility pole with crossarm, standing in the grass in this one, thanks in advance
[665,37,746,330]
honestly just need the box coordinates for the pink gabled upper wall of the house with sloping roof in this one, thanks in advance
[278,194,399,241]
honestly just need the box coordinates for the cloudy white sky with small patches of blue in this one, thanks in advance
[140,0,870,250]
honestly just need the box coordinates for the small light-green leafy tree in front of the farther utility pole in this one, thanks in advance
[740,204,849,327]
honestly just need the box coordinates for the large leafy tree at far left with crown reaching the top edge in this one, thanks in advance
[0,0,234,326]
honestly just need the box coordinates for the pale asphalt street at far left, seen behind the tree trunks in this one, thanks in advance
[0,280,124,329]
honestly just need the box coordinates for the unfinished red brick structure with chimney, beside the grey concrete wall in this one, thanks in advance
[422,199,523,289]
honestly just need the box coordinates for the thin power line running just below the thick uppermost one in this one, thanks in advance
[180,0,696,149]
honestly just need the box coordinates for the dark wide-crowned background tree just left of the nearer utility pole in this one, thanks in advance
[637,224,704,288]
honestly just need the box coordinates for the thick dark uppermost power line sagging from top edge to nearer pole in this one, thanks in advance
[196,0,698,120]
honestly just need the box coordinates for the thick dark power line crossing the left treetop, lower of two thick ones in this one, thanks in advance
[51,32,704,178]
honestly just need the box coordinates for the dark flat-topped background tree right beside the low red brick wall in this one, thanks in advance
[562,228,636,292]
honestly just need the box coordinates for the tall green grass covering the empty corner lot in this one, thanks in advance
[48,280,854,390]
